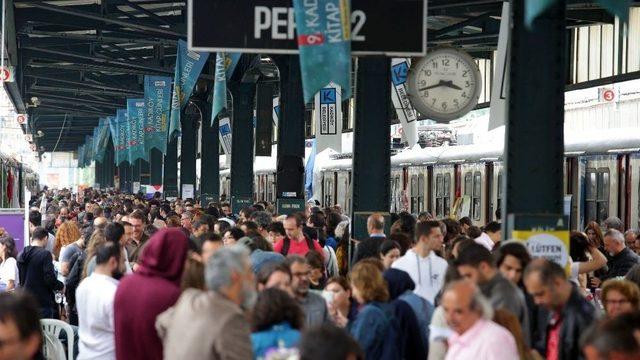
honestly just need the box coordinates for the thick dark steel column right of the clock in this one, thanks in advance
[502,0,567,233]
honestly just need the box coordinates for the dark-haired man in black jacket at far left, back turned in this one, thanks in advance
[18,227,64,319]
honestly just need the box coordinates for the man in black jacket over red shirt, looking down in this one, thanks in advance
[524,259,595,360]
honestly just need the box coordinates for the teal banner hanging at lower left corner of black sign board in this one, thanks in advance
[169,40,209,139]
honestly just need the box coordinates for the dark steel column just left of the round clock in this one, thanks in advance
[351,56,391,240]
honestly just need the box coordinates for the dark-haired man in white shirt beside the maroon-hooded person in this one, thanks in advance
[76,241,124,360]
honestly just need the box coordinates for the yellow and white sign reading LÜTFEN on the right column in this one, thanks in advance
[511,230,571,272]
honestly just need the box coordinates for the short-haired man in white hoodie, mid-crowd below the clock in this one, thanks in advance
[391,220,447,304]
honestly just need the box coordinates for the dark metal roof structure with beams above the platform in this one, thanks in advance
[6,0,636,152]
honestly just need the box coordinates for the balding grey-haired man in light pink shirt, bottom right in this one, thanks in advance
[442,280,520,360]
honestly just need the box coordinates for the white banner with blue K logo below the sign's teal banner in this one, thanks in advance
[314,83,342,153]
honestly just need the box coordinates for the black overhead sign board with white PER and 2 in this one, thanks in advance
[188,0,427,57]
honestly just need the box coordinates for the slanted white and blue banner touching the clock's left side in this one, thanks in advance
[391,58,418,147]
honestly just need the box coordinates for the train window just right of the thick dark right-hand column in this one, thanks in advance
[585,168,610,223]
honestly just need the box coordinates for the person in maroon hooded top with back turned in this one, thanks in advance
[114,228,189,360]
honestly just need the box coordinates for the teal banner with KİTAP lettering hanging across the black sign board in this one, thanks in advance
[293,0,352,103]
